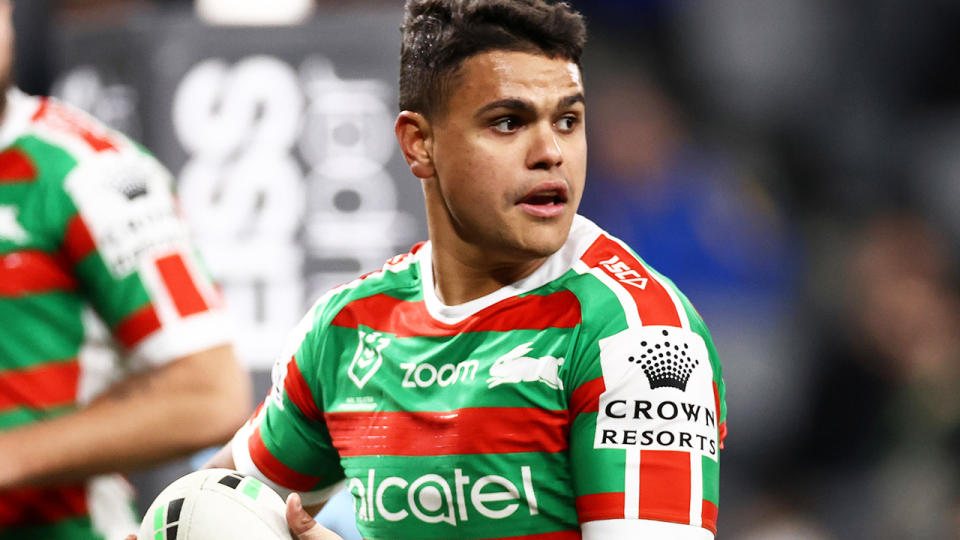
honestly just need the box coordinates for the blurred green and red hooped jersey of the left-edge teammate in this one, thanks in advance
[0,89,230,540]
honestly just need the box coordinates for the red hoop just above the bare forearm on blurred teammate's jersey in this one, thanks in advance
[0,359,80,411]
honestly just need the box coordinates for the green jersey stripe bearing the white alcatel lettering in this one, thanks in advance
[344,453,578,539]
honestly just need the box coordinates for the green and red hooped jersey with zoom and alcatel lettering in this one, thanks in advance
[232,217,726,540]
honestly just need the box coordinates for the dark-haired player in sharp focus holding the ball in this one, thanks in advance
[202,0,726,540]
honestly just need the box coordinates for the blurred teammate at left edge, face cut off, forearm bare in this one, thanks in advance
[0,0,250,540]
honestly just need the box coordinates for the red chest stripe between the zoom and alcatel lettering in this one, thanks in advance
[324,407,568,457]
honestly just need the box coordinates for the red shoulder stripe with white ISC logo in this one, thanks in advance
[580,235,680,326]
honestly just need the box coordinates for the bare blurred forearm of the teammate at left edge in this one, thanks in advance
[0,347,250,489]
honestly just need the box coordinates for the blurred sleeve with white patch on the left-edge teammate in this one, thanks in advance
[22,143,231,365]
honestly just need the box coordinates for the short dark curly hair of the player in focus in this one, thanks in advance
[399,0,587,118]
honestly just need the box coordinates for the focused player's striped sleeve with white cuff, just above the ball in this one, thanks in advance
[230,299,344,505]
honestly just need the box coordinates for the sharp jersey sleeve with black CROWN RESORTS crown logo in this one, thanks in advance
[563,247,726,538]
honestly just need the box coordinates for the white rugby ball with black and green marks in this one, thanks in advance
[137,469,292,540]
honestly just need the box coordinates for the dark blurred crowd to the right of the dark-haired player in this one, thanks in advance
[17,0,960,540]
